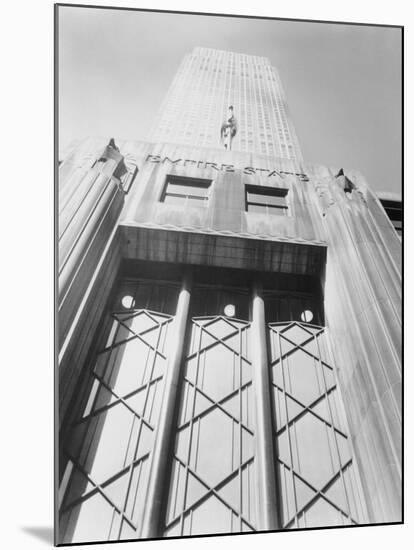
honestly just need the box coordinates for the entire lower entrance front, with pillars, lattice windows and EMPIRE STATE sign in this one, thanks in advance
[58,138,401,542]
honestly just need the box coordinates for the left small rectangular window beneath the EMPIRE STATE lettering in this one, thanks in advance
[160,175,212,206]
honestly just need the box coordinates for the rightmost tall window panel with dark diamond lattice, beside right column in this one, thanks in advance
[268,322,364,529]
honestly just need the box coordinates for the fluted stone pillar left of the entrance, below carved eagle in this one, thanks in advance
[58,140,126,349]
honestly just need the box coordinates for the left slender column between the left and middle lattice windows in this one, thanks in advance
[140,273,192,538]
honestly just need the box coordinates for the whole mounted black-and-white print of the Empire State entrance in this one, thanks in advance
[54,3,404,546]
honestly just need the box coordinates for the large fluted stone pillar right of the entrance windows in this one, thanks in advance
[324,183,403,523]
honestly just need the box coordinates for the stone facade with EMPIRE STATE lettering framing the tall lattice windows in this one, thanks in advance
[58,138,402,536]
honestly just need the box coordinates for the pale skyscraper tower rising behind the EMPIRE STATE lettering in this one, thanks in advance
[150,48,302,160]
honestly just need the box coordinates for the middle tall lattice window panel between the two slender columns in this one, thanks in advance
[165,316,256,536]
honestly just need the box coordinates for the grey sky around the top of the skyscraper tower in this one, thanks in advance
[58,7,401,195]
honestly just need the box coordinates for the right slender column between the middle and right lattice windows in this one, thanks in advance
[252,282,278,531]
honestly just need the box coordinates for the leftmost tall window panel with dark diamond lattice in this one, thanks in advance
[60,310,172,542]
